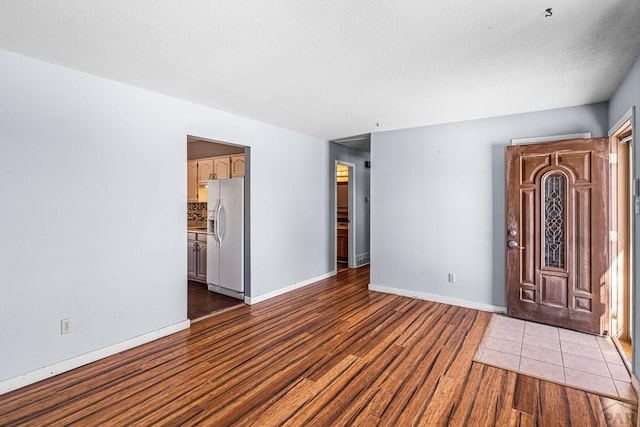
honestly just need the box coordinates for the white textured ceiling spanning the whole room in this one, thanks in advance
[0,0,640,139]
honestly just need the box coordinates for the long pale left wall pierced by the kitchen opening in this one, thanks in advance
[0,51,333,381]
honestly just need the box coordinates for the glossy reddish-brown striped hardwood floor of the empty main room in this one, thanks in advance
[0,267,636,426]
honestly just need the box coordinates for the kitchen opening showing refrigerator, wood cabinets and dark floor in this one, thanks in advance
[186,136,249,322]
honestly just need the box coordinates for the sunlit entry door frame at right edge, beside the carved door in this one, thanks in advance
[608,107,640,360]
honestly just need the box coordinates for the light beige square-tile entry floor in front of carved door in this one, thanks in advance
[474,315,637,402]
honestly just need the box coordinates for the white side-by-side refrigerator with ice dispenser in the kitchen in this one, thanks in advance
[207,178,244,299]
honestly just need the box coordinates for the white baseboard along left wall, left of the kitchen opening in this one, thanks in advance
[0,319,191,395]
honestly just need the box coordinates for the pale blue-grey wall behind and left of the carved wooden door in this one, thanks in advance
[371,103,607,309]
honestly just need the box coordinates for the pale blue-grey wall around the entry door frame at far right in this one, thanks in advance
[609,53,640,374]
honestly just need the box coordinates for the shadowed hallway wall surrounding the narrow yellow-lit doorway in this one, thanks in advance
[328,143,371,259]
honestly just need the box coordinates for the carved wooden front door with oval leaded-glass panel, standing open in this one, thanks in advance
[505,138,609,334]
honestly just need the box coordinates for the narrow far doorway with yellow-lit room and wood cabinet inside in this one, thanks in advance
[334,160,357,270]
